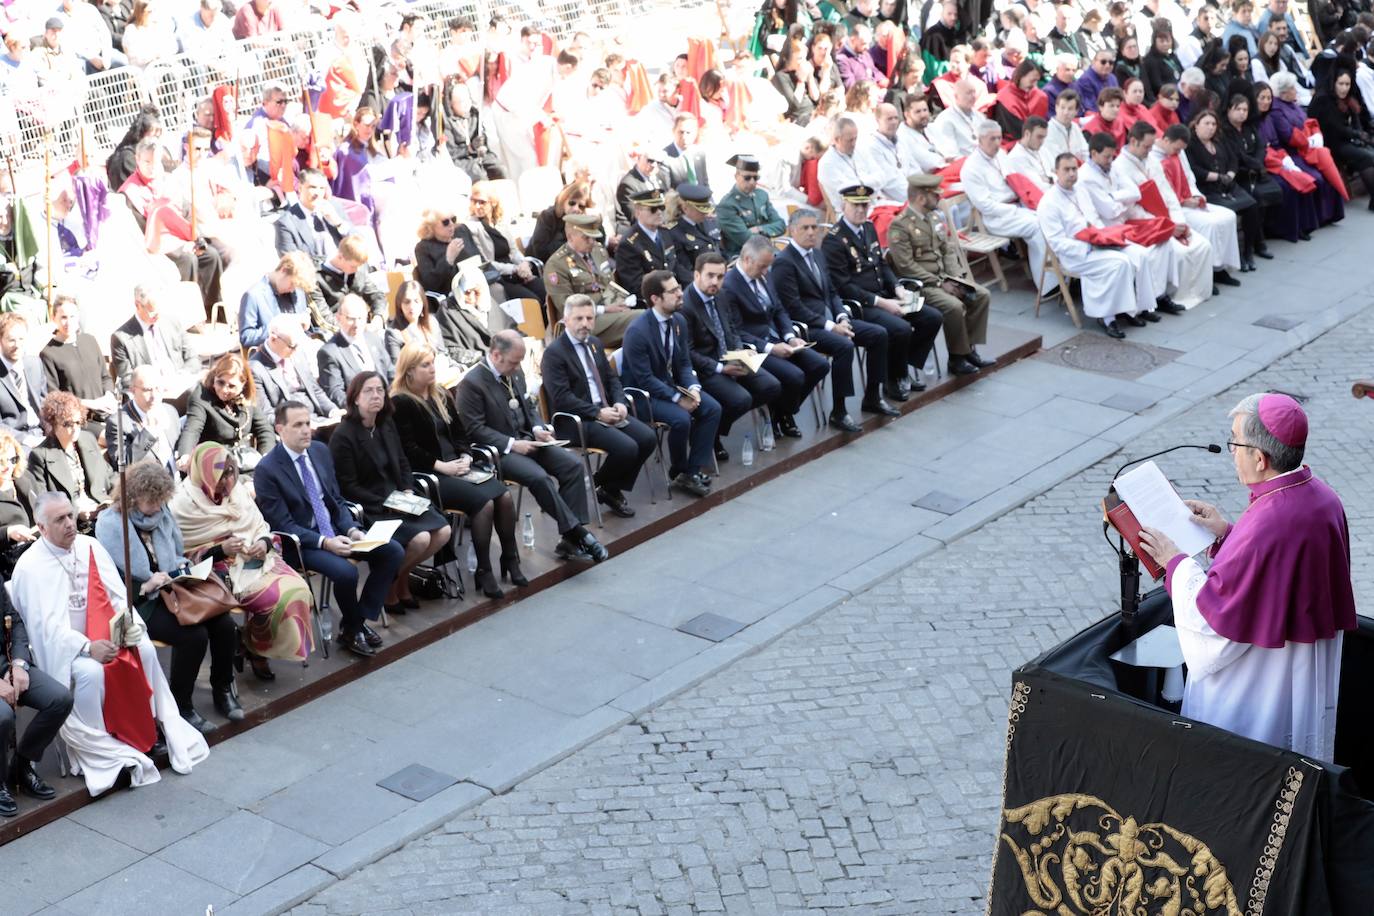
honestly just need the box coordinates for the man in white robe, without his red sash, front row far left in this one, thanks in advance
[10,493,210,795]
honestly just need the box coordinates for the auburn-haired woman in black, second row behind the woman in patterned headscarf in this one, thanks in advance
[176,347,276,474]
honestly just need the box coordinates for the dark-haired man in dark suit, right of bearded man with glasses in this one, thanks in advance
[683,251,782,461]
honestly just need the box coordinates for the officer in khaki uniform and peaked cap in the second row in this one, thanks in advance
[544,213,635,349]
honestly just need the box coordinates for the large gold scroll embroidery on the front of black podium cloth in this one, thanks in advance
[1002,791,1247,916]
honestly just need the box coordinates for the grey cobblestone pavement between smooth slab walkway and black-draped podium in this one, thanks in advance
[293,313,1374,916]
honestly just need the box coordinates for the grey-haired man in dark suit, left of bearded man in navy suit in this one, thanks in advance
[540,295,657,518]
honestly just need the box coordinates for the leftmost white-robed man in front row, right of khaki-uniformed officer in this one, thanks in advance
[1036,152,1154,327]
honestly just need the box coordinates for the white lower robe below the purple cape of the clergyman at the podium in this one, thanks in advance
[1169,558,1344,761]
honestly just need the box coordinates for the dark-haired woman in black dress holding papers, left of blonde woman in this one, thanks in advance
[330,369,452,614]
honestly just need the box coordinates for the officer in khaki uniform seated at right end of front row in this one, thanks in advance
[888,174,998,375]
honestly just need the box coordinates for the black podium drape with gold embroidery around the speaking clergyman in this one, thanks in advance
[989,589,1374,916]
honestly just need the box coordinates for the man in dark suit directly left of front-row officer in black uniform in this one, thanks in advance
[771,207,897,433]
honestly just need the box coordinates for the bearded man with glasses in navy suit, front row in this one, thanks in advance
[620,271,720,496]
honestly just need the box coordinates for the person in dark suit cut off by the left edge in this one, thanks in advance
[0,588,73,817]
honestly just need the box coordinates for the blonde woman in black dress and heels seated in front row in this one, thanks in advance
[392,343,529,597]
